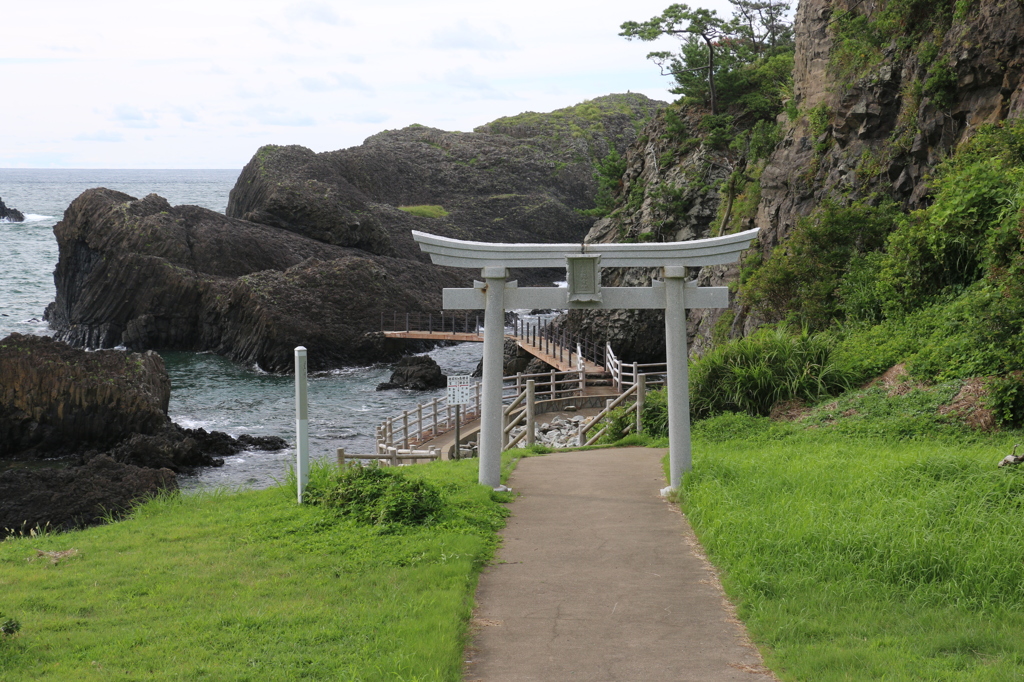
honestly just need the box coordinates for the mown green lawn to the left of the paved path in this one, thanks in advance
[0,450,510,682]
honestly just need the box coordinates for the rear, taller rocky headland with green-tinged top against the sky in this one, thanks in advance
[227,93,664,260]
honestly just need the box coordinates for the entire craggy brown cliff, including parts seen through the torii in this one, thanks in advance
[567,0,1024,361]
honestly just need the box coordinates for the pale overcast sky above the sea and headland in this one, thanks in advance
[0,0,731,168]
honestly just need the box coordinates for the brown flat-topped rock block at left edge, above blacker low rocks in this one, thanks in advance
[0,334,171,457]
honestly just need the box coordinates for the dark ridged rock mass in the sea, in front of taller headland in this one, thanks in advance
[46,188,469,372]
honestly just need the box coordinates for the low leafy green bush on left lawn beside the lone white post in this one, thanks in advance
[303,463,444,525]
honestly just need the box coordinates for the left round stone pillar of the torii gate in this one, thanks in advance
[478,267,508,488]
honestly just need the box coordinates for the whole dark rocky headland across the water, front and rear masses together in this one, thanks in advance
[46,94,664,372]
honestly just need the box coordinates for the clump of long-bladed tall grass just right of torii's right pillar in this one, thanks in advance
[690,329,850,419]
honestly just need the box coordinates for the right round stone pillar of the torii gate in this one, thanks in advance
[665,265,692,491]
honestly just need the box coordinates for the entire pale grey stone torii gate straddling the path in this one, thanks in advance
[413,229,758,489]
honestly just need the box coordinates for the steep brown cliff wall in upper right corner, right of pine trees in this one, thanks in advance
[757,0,1024,256]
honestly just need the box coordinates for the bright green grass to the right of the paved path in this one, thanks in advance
[681,409,1024,682]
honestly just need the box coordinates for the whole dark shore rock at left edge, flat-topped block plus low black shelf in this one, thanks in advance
[0,334,286,538]
